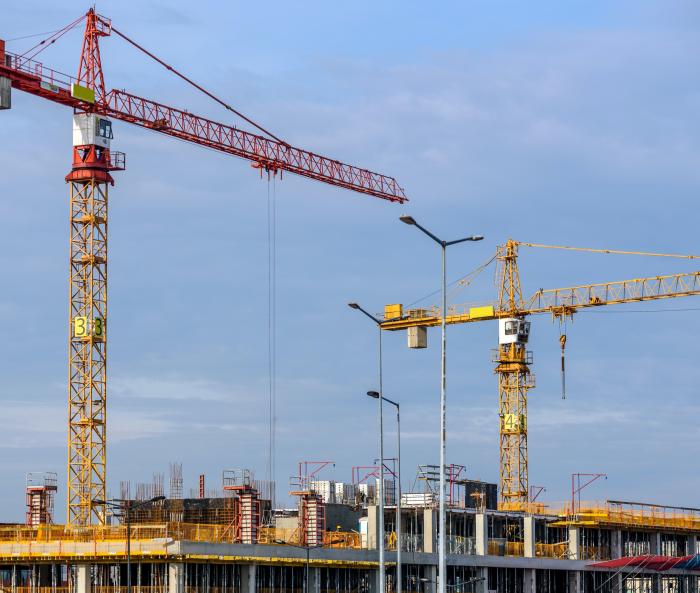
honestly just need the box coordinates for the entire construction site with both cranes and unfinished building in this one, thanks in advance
[0,8,700,593]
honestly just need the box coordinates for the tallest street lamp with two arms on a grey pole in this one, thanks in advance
[399,216,484,593]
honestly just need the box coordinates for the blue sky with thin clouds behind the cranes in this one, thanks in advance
[0,0,700,521]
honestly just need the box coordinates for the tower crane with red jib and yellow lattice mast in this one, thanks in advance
[0,8,407,526]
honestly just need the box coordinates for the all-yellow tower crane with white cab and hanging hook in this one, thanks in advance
[381,239,700,510]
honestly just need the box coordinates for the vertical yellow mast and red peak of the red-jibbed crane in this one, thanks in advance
[66,10,120,525]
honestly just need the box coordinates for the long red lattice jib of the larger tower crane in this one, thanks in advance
[0,47,407,203]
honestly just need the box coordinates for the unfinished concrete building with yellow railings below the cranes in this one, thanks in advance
[0,468,700,593]
